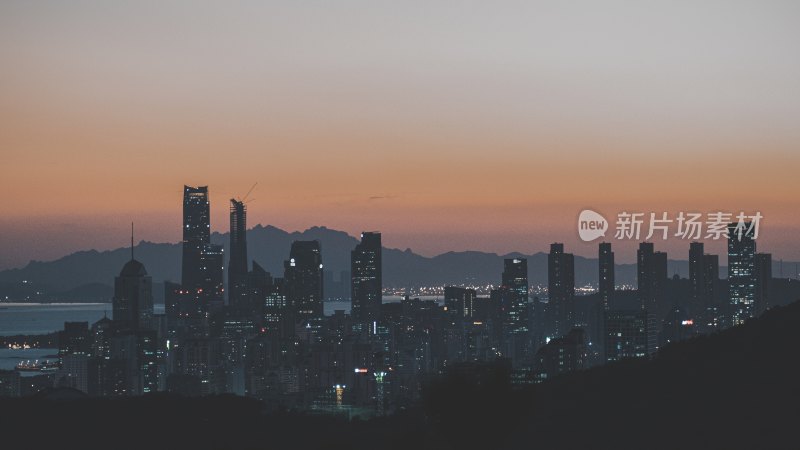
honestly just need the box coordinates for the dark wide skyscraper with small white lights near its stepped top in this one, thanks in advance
[284,241,323,321]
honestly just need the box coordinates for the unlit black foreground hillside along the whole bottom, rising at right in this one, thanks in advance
[0,303,800,449]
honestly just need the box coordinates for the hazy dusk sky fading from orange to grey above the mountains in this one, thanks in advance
[0,0,800,269]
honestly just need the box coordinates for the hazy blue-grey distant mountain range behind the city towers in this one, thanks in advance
[0,225,780,300]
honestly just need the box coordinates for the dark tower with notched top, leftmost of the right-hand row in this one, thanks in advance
[547,243,575,337]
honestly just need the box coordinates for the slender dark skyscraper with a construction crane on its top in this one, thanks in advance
[228,199,248,310]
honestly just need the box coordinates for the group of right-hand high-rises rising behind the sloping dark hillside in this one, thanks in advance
[533,223,773,375]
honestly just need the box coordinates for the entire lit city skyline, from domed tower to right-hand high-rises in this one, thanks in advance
[54,186,772,402]
